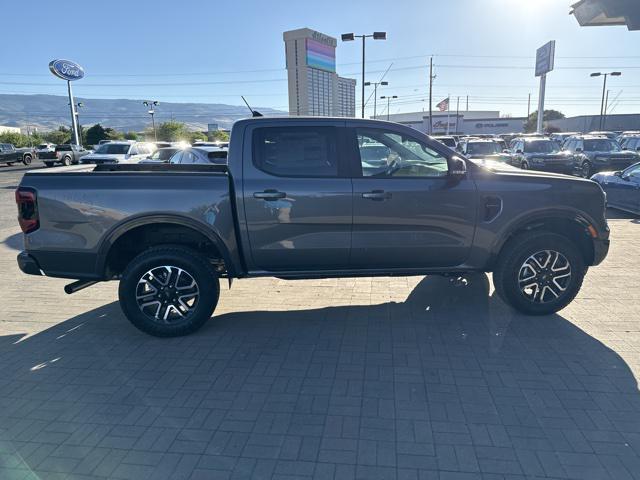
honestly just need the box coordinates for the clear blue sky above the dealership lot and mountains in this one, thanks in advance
[5,0,640,116]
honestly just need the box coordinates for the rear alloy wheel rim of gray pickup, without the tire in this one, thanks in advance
[136,265,200,324]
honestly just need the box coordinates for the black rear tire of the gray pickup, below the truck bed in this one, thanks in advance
[118,246,220,337]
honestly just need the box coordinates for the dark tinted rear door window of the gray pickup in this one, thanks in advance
[253,127,338,177]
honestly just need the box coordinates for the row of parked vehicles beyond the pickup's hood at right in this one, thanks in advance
[437,132,640,215]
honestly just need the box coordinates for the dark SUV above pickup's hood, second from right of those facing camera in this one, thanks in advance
[511,138,573,175]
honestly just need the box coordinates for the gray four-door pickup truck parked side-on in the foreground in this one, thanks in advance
[16,118,609,336]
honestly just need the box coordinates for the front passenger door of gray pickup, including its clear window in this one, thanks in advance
[349,124,477,270]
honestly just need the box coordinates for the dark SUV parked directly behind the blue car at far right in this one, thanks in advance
[564,135,639,178]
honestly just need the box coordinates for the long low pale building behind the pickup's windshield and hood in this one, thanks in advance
[375,110,527,135]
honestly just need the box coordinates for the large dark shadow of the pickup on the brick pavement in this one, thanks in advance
[0,275,640,479]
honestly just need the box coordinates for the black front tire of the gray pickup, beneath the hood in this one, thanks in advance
[493,232,586,315]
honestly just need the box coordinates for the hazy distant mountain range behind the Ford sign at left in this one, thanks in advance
[0,94,287,131]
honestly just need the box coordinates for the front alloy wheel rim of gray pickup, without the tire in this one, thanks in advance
[518,250,571,303]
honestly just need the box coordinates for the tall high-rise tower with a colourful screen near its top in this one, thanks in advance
[283,28,356,117]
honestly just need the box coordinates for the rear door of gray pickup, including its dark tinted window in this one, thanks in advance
[243,121,353,272]
